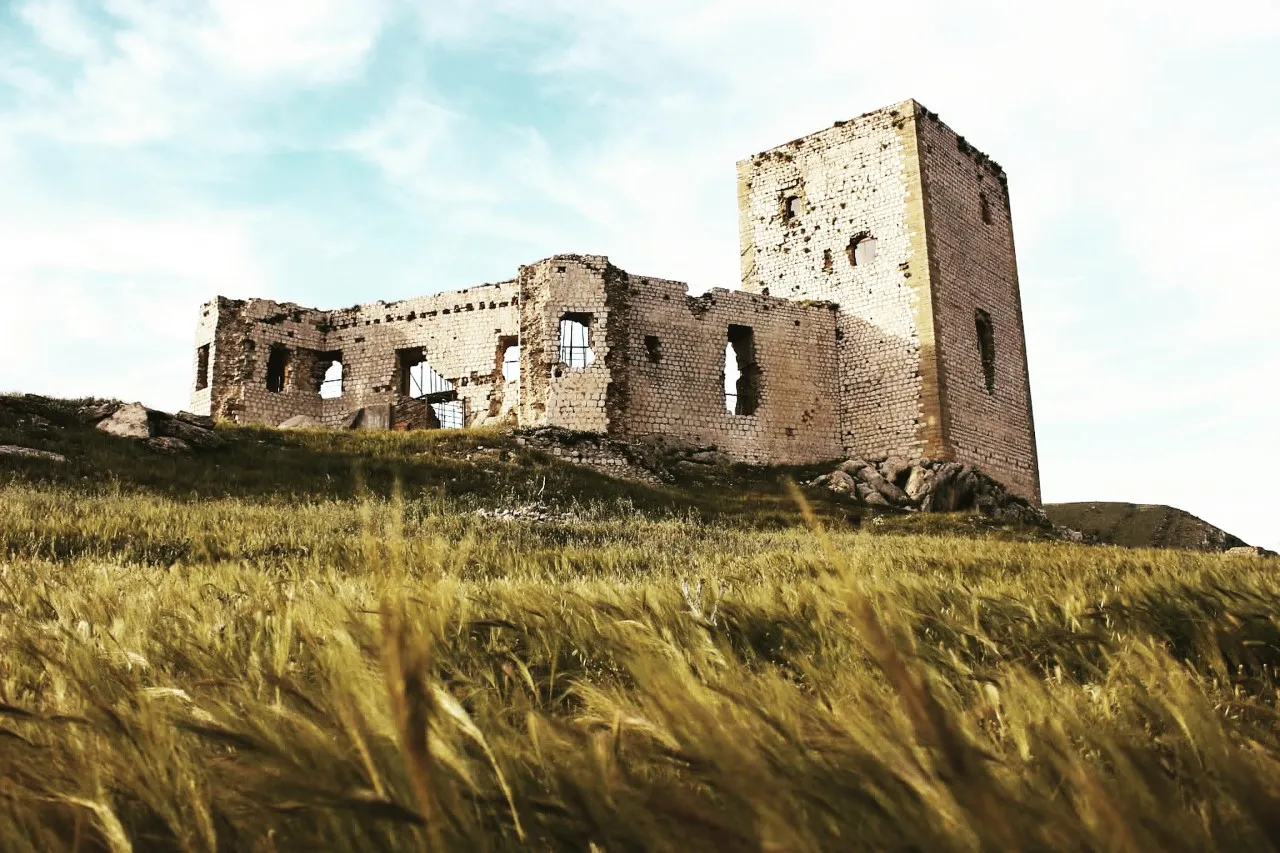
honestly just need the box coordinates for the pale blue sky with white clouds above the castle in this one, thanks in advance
[0,0,1280,548]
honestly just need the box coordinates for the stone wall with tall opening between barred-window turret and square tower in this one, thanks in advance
[614,275,841,465]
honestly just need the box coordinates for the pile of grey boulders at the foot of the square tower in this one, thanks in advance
[809,457,1050,526]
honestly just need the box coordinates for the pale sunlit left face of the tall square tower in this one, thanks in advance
[737,102,945,466]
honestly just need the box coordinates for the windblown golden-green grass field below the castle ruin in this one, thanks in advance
[0,401,1280,853]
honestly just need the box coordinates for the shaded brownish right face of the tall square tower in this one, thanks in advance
[918,109,1039,503]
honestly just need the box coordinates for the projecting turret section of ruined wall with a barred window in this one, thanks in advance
[518,255,617,433]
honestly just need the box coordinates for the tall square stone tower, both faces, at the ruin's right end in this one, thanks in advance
[737,100,1041,503]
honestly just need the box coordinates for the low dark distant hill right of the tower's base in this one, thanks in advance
[1044,502,1244,551]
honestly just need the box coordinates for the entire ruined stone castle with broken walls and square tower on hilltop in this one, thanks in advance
[192,100,1039,505]
